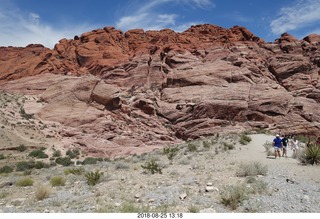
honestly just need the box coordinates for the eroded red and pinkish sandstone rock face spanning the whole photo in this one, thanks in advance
[0,25,320,156]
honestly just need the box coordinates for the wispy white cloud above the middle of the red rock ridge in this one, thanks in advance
[116,0,215,32]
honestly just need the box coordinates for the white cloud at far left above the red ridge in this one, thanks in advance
[0,6,97,48]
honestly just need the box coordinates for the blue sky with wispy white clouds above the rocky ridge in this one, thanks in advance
[0,0,320,48]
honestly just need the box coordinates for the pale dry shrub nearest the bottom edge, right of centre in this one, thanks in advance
[220,184,248,210]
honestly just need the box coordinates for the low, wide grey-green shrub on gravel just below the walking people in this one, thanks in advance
[236,162,268,177]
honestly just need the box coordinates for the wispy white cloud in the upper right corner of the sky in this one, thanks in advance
[270,0,320,34]
